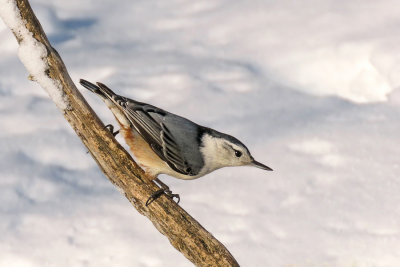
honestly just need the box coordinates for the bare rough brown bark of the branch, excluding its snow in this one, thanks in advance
[1,0,239,266]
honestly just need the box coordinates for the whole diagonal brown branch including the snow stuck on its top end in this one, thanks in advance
[0,0,239,266]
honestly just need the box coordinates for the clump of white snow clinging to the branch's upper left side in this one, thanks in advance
[0,0,68,110]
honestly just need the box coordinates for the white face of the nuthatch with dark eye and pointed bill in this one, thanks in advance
[201,136,271,170]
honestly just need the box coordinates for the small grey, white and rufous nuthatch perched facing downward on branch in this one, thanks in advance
[79,79,272,206]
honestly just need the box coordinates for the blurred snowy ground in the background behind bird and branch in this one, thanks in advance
[0,0,400,267]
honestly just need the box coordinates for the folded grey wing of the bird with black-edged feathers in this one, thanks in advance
[119,101,203,176]
